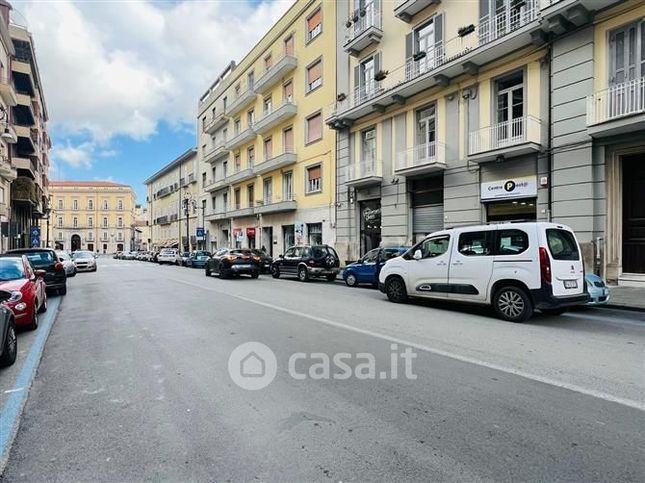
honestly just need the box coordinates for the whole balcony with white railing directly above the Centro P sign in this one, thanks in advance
[468,116,542,163]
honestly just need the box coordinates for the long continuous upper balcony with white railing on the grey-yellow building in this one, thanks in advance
[327,0,540,128]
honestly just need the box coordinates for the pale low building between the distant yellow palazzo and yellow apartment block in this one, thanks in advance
[144,148,201,250]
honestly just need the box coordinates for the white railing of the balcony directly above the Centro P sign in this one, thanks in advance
[468,116,541,156]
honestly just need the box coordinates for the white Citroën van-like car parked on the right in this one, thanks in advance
[379,222,589,322]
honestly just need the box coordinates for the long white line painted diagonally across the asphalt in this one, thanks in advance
[171,277,645,411]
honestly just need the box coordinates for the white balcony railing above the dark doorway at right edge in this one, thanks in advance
[587,77,645,126]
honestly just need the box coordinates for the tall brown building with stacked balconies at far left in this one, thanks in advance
[0,1,51,251]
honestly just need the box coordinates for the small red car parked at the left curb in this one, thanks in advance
[0,255,47,330]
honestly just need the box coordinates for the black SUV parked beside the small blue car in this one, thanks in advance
[271,245,340,282]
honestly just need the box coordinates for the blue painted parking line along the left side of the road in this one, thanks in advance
[0,297,61,474]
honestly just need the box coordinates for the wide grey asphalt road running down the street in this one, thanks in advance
[3,259,645,482]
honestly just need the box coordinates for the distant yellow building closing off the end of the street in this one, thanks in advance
[49,180,136,253]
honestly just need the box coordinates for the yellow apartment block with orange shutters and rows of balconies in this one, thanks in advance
[197,0,336,254]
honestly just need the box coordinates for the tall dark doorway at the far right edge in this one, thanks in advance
[622,153,645,273]
